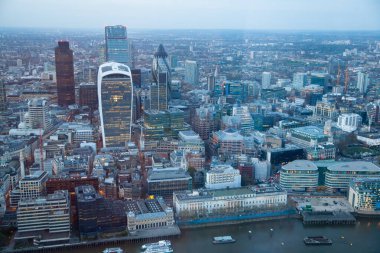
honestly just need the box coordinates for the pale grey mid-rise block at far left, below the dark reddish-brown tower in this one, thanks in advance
[27,98,51,130]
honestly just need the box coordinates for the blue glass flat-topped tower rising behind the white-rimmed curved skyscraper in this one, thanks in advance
[105,25,130,66]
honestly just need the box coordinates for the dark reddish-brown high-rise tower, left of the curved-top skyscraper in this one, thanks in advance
[55,41,75,106]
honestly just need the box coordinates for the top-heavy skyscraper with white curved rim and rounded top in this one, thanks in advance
[98,62,133,147]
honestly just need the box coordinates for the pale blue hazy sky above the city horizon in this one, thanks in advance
[0,0,380,30]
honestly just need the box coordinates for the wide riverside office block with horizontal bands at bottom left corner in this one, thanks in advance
[15,191,71,245]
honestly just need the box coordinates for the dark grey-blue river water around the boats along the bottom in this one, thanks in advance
[70,219,380,253]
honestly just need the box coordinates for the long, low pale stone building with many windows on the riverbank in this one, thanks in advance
[173,185,287,217]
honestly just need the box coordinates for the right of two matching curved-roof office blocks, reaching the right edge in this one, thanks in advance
[325,161,380,192]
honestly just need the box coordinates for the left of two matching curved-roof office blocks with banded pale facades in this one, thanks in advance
[280,160,319,191]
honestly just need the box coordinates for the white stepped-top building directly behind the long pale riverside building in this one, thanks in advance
[205,164,241,189]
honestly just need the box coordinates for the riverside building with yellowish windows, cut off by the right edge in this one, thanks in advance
[348,177,380,213]
